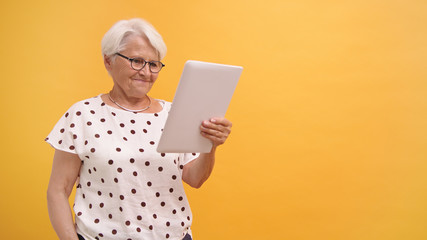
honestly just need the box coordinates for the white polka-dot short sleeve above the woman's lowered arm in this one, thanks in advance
[45,106,79,154]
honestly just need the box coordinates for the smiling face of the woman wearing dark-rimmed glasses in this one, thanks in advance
[105,35,160,98]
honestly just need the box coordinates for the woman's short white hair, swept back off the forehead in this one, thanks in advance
[101,18,167,60]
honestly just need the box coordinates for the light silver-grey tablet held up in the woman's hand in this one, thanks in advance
[157,60,243,153]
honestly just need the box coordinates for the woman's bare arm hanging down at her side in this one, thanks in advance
[47,150,81,240]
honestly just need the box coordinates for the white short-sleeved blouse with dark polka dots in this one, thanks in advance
[46,95,198,240]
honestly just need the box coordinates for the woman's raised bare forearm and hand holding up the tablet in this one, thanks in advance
[182,118,232,188]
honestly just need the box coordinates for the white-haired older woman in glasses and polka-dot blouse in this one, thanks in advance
[46,19,231,240]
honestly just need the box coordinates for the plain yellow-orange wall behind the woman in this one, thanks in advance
[0,0,427,240]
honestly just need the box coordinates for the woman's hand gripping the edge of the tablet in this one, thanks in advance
[200,118,232,148]
